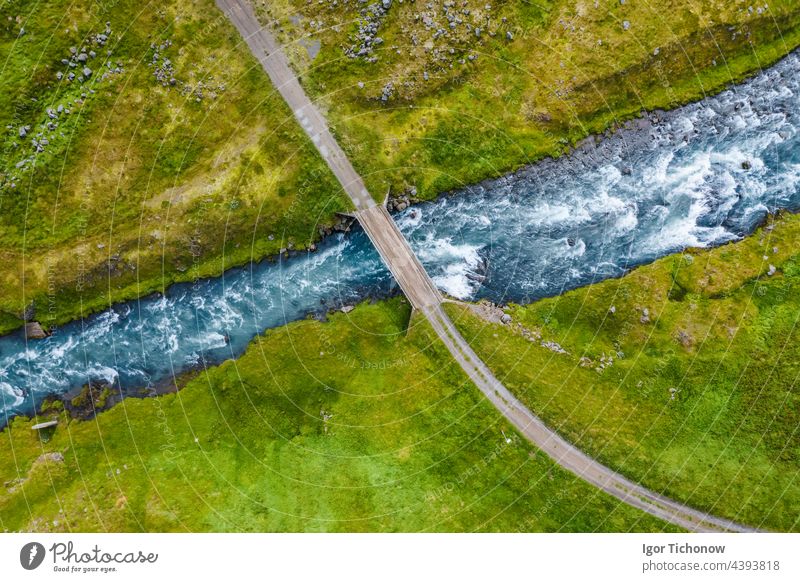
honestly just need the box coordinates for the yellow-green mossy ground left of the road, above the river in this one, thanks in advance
[0,0,349,333]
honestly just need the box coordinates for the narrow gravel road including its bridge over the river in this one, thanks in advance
[216,0,755,532]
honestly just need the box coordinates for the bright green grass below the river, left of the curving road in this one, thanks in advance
[0,299,674,531]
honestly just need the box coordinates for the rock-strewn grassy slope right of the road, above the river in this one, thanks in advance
[254,0,800,199]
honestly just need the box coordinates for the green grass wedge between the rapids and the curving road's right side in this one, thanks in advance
[448,215,800,531]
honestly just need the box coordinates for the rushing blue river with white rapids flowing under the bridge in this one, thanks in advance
[0,53,800,425]
